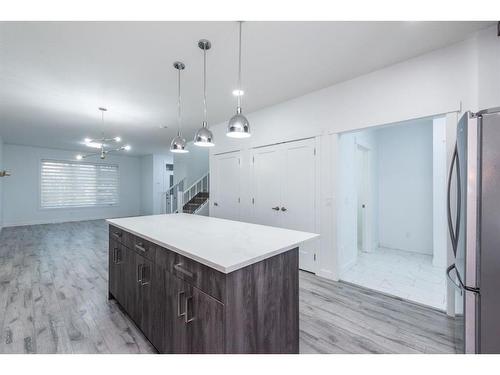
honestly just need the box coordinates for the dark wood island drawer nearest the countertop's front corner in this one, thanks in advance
[168,253,226,302]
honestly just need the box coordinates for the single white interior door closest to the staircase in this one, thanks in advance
[212,152,240,220]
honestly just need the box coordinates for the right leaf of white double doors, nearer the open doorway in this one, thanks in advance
[280,139,319,272]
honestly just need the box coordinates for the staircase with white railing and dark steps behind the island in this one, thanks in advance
[167,173,210,215]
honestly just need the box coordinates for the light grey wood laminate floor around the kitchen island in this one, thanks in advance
[0,220,454,353]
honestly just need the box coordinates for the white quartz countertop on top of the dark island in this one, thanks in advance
[107,214,319,273]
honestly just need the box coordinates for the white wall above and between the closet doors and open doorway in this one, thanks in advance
[210,27,500,279]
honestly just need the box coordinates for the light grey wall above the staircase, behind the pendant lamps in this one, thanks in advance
[174,142,209,187]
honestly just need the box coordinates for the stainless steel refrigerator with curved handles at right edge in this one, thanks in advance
[447,108,500,353]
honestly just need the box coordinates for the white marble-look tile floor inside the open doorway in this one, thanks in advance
[341,248,446,310]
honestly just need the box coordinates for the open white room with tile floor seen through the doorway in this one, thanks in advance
[338,117,447,310]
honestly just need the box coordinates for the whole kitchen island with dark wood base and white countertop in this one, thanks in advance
[108,214,318,353]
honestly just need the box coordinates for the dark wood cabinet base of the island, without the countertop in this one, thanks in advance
[109,214,316,354]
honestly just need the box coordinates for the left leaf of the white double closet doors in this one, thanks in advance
[252,145,283,227]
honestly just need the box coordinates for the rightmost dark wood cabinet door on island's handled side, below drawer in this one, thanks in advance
[185,287,224,354]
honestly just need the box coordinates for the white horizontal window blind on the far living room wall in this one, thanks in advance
[41,160,119,208]
